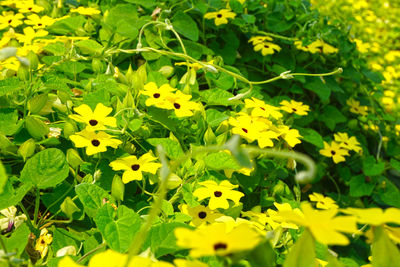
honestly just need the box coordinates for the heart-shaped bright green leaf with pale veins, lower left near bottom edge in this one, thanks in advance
[94,204,140,253]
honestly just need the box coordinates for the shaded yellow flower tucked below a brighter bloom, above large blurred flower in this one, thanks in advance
[179,204,222,227]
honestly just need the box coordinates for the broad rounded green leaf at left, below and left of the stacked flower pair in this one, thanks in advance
[21,148,69,189]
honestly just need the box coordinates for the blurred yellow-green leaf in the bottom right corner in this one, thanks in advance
[371,226,400,267]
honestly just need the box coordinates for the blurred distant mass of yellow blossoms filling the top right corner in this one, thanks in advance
[311,0,400,115]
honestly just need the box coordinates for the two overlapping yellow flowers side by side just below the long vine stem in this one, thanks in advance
[140,82,200,118]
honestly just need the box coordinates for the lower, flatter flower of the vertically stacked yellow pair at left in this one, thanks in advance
[69,129,122,156]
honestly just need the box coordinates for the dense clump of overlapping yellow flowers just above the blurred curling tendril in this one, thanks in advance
[228,97,309,148]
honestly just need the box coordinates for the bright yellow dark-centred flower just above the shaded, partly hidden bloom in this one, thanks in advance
[193,180,244,210]
